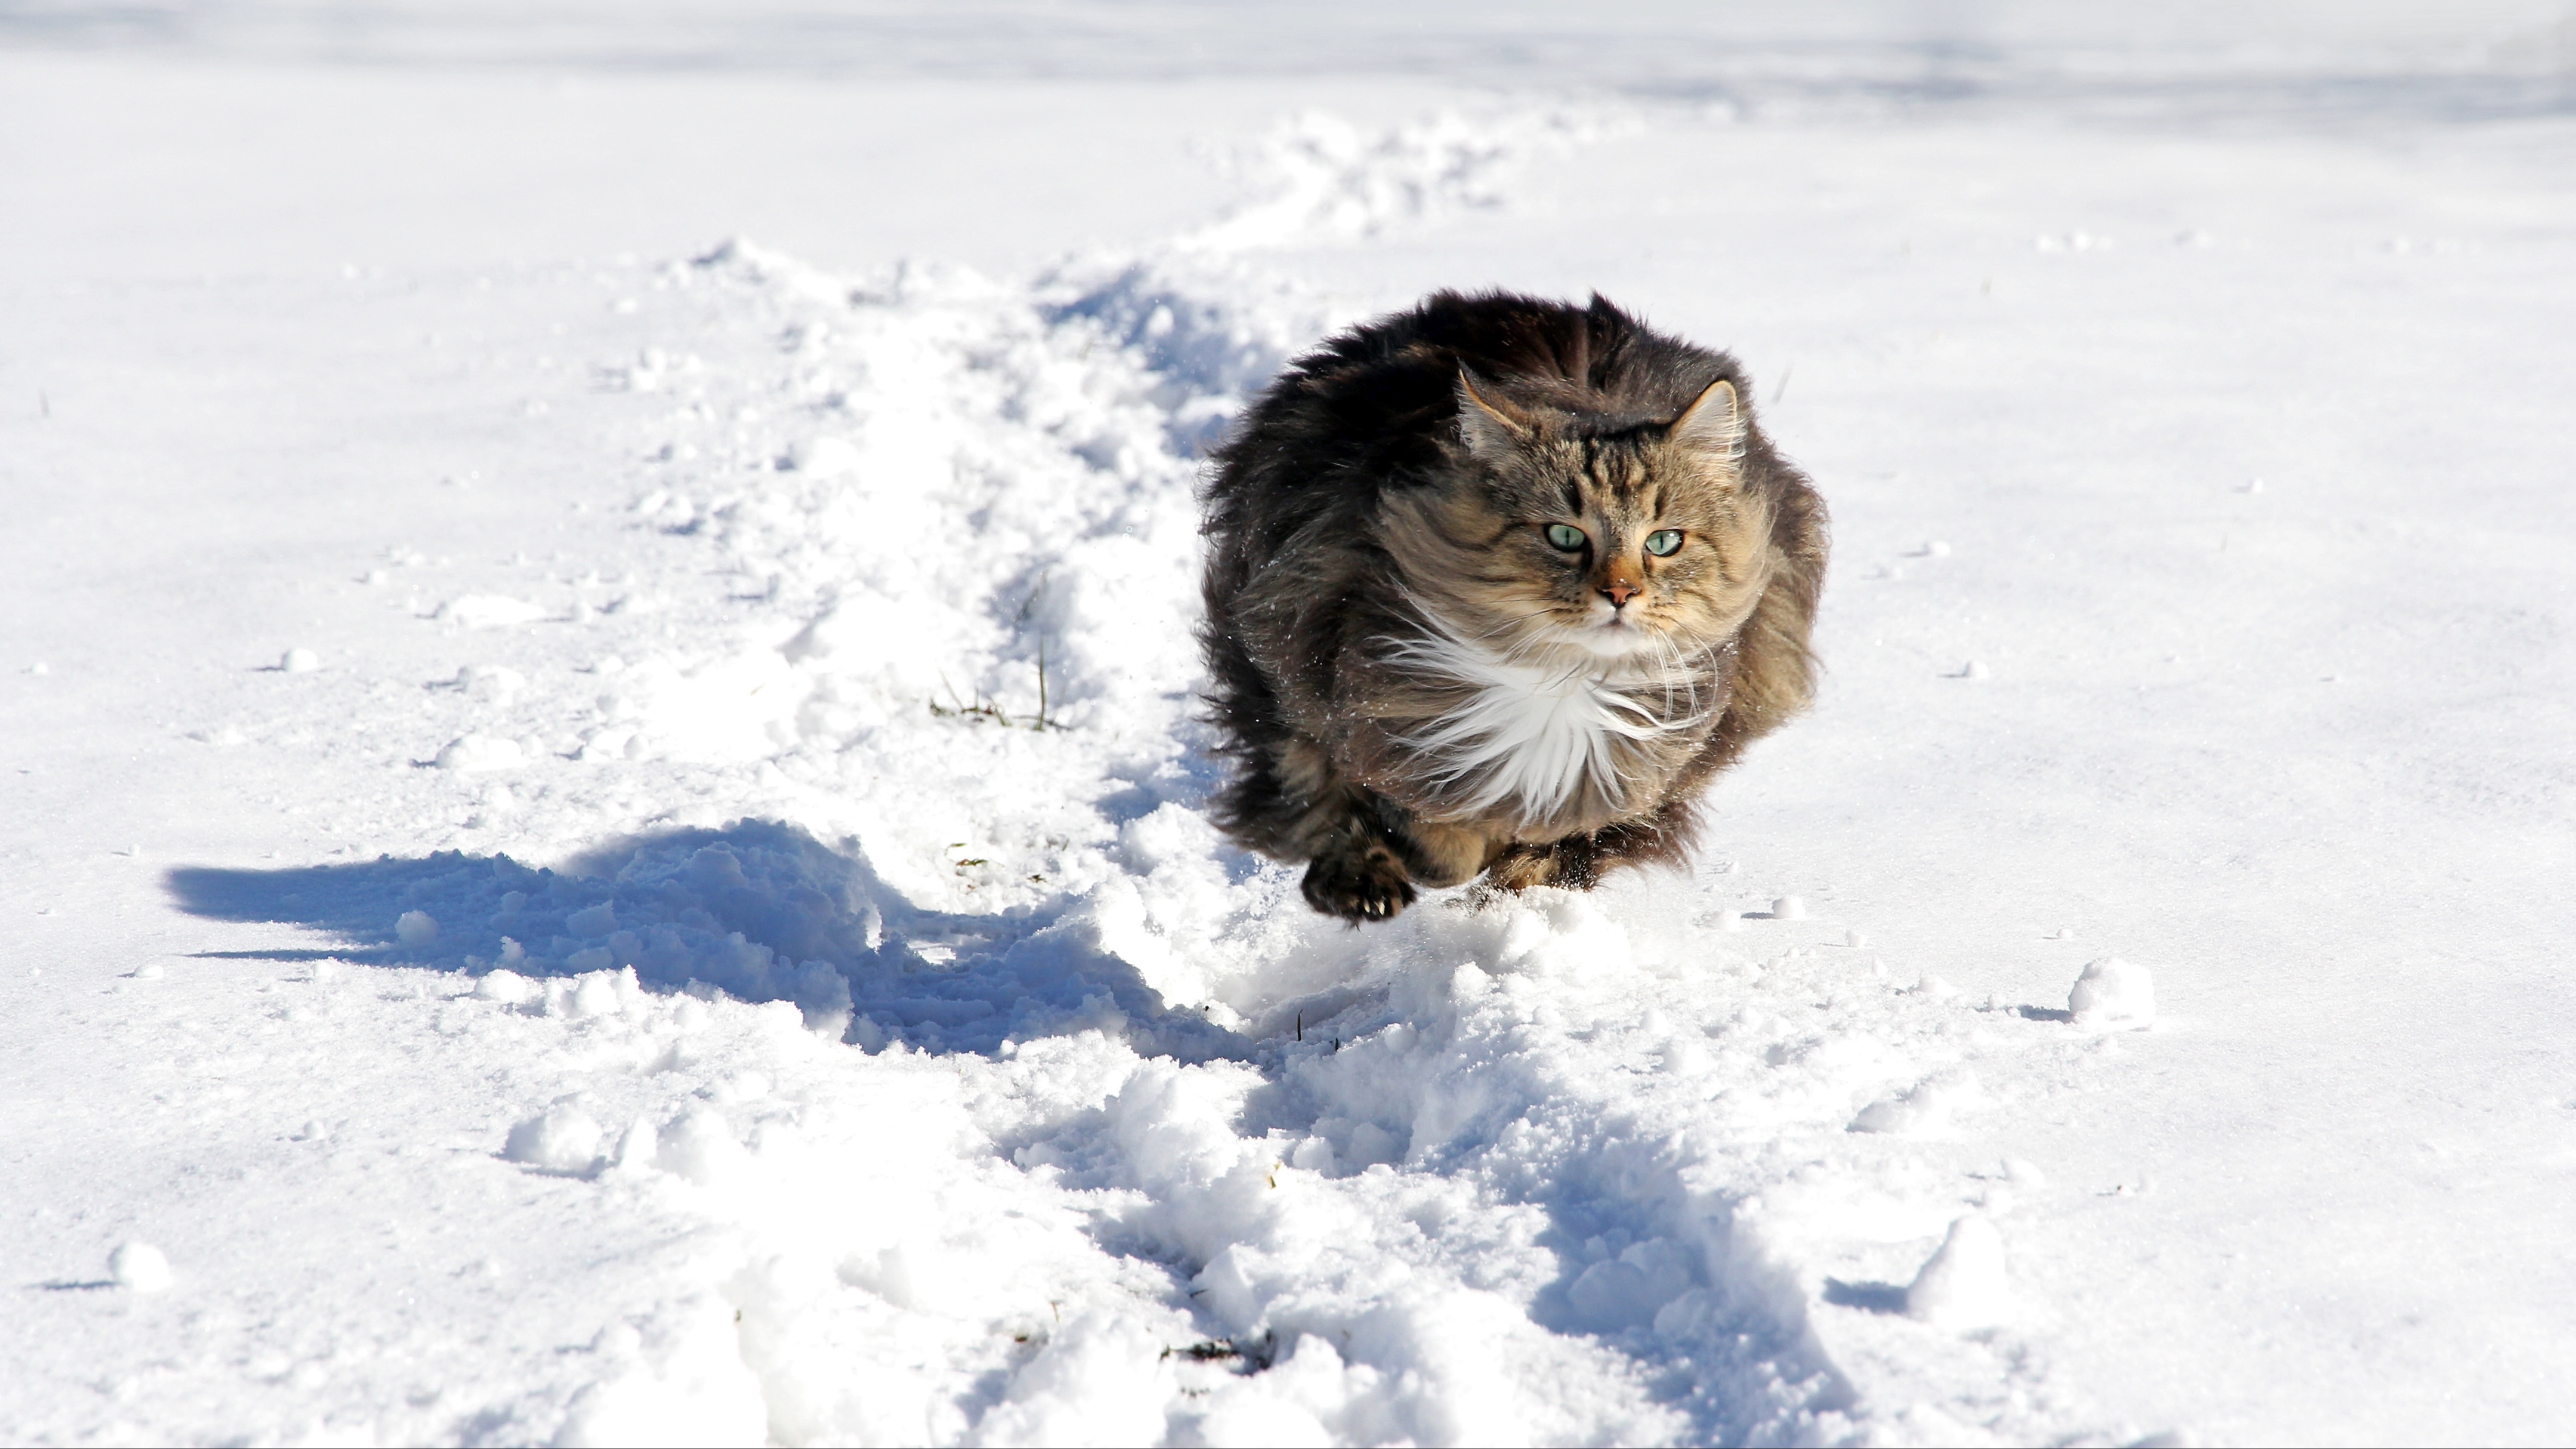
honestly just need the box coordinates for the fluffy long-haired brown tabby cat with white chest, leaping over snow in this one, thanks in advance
[1200,291,1826,921]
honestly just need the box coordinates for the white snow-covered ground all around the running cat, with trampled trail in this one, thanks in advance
[0,5,2576,1444]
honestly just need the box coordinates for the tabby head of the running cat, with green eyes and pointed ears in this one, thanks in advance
[1386,371,1770,659]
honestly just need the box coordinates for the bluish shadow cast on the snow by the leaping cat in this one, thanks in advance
[165,821,1249,1060]
